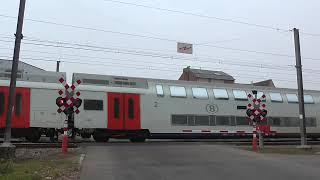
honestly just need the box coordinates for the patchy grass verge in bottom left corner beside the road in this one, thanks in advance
[0,152,80,180]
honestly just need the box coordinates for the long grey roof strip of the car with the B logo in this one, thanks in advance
[73,73,319,93]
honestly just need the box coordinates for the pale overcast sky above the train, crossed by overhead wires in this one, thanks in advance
[0,0,320,89]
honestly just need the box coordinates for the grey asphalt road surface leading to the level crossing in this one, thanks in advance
[81,142,320,180]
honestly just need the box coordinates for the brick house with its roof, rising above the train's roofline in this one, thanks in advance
[179,66,235,83]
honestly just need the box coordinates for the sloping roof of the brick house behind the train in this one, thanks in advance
[185,68,235,81]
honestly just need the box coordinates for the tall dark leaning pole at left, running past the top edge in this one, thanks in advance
[0,0,26,158]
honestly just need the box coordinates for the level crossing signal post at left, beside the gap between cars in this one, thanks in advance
[56,78,82,154]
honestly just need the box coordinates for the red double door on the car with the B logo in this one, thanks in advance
[108,93,141,130]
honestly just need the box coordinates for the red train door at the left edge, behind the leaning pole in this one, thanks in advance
[0,87,30,128]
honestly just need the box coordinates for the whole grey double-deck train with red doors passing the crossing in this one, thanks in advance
[0,72,320,142]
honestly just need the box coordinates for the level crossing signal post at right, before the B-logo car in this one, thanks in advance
[246,90,270,151]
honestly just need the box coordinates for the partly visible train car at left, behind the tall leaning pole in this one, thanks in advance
[0,71,66,141]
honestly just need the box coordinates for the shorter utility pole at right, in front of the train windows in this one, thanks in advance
[293,28,307,148]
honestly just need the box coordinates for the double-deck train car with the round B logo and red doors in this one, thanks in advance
[73,73,320,142]
